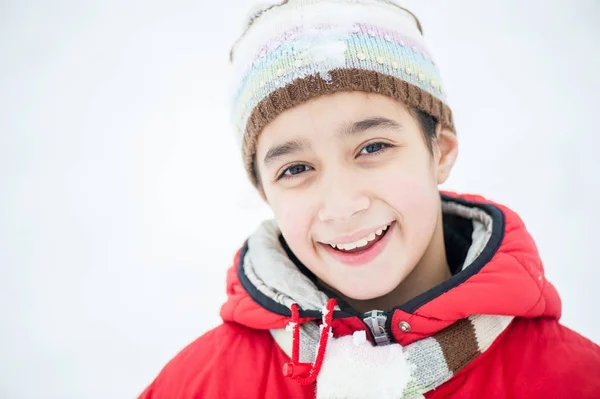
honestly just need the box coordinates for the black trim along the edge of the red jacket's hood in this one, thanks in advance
[237,194,505,318]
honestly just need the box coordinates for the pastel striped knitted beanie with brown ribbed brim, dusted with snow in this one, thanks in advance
[231,0,454,186]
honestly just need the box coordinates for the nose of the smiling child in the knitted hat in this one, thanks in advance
[318,170,371,222]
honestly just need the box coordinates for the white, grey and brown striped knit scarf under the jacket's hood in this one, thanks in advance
[274,315,513,399]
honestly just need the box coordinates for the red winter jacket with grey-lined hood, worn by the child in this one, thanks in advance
[140,193,600,399]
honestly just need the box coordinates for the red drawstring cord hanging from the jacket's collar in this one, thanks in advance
[283,298,337,385]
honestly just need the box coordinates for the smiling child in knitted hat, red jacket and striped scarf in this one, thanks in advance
[141,0,600,399]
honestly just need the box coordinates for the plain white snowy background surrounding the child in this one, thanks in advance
[0,0,600,399]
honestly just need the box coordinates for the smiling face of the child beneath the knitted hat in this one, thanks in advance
[256,92,457,300]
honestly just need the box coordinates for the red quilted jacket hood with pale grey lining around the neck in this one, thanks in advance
[221,192,561,343]
